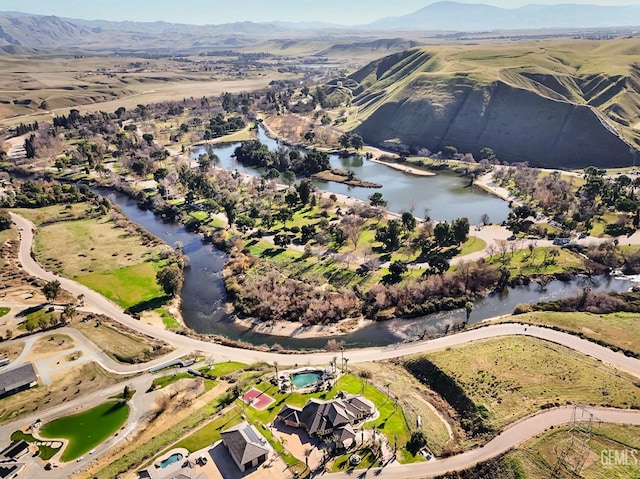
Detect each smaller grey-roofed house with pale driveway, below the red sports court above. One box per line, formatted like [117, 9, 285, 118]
[221, 421, 271, 472]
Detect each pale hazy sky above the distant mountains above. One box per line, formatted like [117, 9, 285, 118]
[0, 0, 640, 25]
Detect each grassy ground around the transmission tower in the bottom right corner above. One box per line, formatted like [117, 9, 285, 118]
[506, 424, 640, 479]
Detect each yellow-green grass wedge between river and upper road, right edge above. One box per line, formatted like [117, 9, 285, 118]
[496, 311, 640, 354]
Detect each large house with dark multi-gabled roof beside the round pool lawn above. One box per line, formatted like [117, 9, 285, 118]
[276, 391, 375, 447]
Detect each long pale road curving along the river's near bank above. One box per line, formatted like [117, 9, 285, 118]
[11, 213, 640, 377]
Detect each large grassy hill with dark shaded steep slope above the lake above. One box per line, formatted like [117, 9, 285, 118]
[342, 39, 640, 171]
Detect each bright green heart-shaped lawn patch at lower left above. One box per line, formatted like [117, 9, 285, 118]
[40, 402, 129, 462]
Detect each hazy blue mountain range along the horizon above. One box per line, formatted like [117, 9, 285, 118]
[0, 2, 640, 52]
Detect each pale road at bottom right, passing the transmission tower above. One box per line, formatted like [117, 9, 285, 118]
[322, 407, 640, 479]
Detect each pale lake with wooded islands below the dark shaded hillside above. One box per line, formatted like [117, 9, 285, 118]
[192, 129, 509, 224]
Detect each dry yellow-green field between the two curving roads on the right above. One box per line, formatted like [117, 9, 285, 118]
[426, 337, 640, 429]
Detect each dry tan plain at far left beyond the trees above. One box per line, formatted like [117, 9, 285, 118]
[0, 55, 287, 125]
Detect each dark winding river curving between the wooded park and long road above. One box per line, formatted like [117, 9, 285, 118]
[96, 190, 631, 349]
